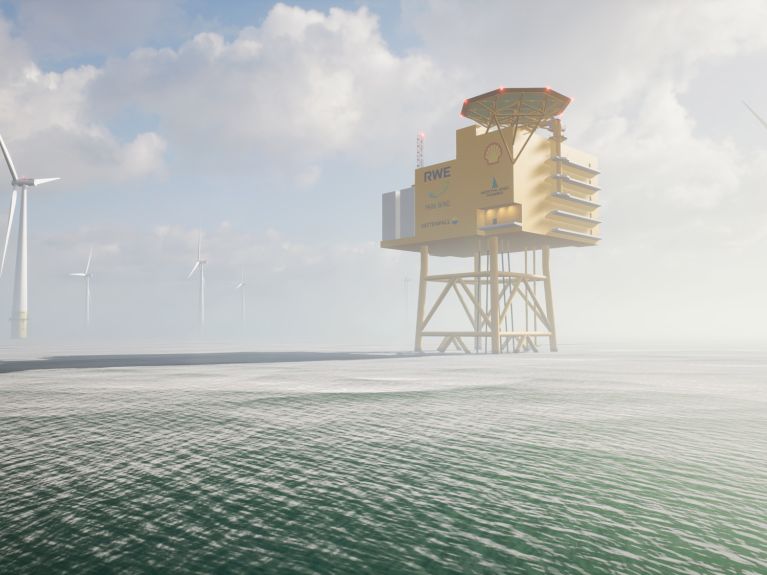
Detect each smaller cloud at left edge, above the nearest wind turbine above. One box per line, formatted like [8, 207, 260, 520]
[0, 15, 166, 189]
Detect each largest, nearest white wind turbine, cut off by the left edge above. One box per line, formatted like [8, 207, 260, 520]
[0, 132, 59, 339]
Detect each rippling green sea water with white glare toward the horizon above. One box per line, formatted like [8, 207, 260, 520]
[0, 350, 767, 575]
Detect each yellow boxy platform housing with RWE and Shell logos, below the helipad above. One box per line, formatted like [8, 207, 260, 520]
[381, 110, 599, 255]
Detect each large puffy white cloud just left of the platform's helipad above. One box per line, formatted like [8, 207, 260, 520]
[88, 4, 455, 180]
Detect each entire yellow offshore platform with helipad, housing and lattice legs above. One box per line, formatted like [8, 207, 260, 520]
[381, 88, 600, 353]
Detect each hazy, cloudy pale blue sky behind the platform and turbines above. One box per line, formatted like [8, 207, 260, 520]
[0, 0, 767, 349]
